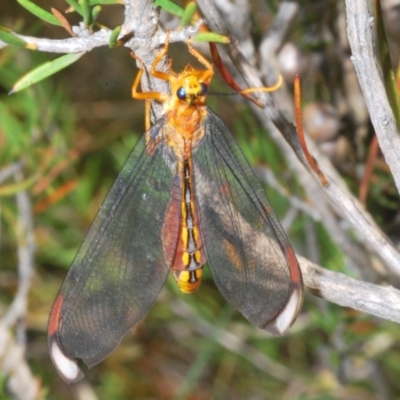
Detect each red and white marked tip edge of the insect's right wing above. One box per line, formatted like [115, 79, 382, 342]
[263, 245, 303, 336]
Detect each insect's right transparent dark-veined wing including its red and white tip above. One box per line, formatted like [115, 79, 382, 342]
[193, 110, 302, 334]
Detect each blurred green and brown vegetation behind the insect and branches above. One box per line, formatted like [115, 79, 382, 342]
[0, 0, 400, 400]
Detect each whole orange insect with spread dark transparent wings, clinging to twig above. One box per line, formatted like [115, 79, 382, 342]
[48, 38, 303, 382]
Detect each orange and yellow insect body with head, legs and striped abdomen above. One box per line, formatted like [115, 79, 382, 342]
[132, 45, 214, 293]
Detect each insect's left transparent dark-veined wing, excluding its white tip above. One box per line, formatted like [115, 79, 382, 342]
[49, 120, 174, 366]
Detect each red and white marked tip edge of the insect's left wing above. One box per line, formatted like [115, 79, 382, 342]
[48, 294, 84, 383]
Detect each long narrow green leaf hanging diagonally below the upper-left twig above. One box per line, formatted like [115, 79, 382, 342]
[10, 53, 85, 94]
